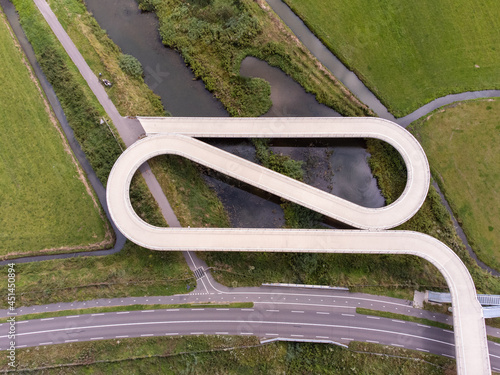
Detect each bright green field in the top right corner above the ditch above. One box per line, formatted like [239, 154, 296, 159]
[285, 0, 500, 117]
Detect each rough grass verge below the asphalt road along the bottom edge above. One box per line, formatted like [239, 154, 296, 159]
[1, 336, 455, 375]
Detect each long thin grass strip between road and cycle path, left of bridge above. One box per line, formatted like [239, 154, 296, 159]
[0, 302, 253, 323]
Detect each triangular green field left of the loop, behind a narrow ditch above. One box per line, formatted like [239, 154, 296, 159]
[0, 13, 111, 256]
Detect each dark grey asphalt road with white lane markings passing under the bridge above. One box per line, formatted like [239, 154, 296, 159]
[0, 303, 500, 371]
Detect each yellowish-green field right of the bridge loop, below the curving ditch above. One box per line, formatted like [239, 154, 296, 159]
[413, 99, 500, 269]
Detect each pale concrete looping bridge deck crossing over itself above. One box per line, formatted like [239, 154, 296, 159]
[107, 117, 491, 374]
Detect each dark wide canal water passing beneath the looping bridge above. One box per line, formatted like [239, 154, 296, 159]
[85, 0, 384, 228]
